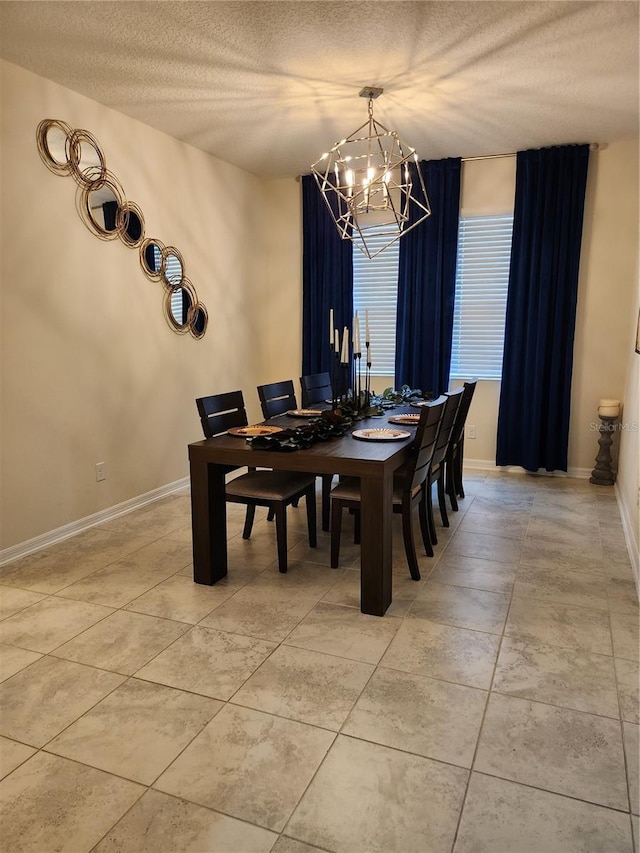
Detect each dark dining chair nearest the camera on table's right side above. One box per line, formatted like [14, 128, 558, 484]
[331, 397, 447, 581]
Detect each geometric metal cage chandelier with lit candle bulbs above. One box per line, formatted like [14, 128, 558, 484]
[311, 86, 431, 258]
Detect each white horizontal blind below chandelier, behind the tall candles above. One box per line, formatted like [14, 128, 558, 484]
[353, 229, 399, 376]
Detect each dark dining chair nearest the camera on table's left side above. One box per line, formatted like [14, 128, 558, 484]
[196, 391, 317, 573]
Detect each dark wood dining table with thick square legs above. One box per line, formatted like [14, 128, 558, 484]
[189, 410, 415, 616]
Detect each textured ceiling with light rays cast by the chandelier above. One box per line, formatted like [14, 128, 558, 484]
[0, 0, 639, 177]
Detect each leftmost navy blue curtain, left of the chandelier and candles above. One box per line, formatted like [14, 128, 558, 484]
[302, 175, 353, 376]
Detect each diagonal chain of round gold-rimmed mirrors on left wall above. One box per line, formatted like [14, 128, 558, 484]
[36, 119, 209, 339]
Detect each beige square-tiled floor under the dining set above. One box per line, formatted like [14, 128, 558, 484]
[0, 472, 640, 853]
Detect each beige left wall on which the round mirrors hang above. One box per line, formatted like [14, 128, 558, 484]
[0, 62, 284, 550]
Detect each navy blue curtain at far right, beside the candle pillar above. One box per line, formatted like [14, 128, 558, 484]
[496, 145, 589, 471]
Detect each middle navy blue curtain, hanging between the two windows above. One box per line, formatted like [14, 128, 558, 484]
[395, 157, 461, 397]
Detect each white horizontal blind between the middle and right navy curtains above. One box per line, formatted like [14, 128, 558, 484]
[451, 213, 513, 379]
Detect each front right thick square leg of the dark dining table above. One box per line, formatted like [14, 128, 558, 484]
[360, 472, 393, 616]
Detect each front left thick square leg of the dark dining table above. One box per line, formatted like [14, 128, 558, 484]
[190, 460, 227, 586]
